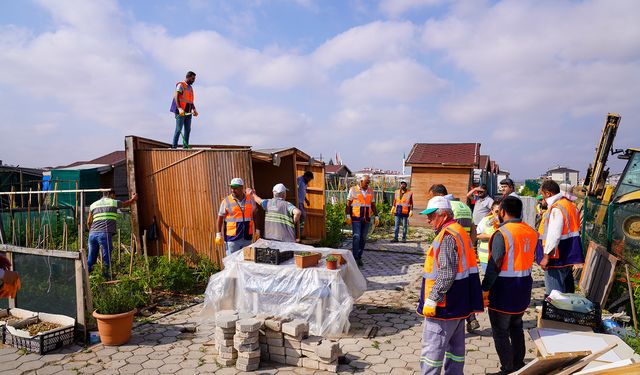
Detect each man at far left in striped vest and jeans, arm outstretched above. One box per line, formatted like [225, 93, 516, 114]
[87, 189, 138, 274]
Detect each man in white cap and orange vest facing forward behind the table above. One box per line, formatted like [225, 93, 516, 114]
[216, 177, 256, 255]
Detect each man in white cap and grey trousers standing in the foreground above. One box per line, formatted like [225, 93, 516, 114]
[416, 196, 484, 375]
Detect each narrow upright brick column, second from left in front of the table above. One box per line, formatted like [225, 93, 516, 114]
[233, 318, 262, 371]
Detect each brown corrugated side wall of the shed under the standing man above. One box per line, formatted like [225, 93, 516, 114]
[128, 140, 252, 262]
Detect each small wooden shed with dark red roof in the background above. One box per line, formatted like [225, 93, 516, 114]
[406, 143, 480, 225]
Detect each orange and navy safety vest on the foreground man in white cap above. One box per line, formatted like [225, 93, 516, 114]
[416, 221, 484, 319]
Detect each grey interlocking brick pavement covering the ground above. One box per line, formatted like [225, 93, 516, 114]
[0, 240, 543, 375]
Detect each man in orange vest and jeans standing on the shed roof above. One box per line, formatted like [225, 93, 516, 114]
[170, 71, 198, 148]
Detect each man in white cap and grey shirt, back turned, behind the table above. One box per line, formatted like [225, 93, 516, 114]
[247, 184, 302, 242]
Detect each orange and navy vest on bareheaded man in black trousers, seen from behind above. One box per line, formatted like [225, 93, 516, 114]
[489, 222, 538, 314]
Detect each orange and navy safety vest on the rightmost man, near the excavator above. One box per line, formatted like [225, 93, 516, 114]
[536, 197, 584, 268]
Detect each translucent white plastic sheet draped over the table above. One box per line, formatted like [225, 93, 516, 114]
[201, 239, 367, 337]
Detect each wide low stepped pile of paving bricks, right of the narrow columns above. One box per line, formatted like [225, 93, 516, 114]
[260, 318, 340, 372]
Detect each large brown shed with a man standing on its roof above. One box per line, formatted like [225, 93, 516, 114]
[125, 136, 325, 264]
